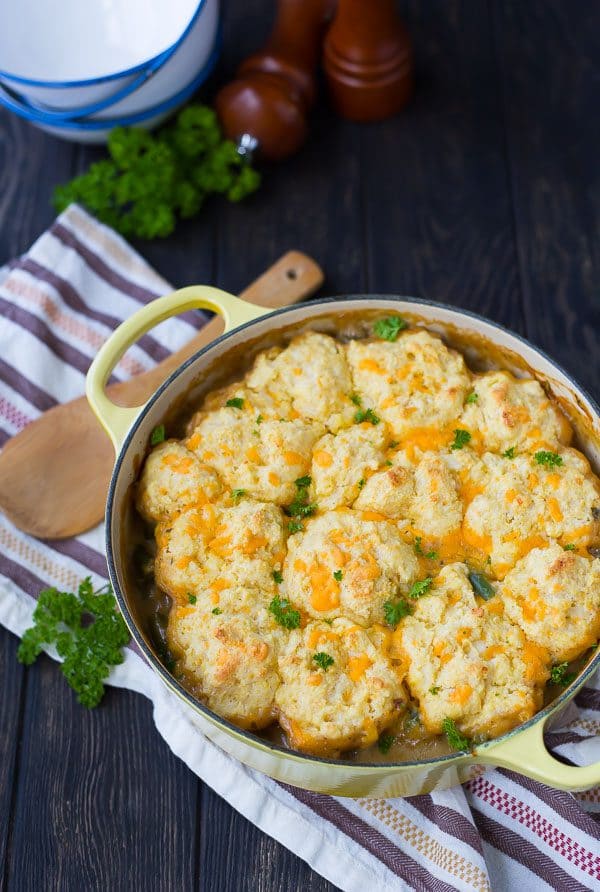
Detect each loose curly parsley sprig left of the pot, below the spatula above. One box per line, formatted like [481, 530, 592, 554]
[17, 576, 129, 709]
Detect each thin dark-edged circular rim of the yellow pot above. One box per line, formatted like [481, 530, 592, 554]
[105, 294, 600, 771]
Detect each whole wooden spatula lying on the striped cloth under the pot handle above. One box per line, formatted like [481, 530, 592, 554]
[0, 251, 323, 539]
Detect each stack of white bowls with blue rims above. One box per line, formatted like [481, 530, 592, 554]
[0, 0, 220, 143]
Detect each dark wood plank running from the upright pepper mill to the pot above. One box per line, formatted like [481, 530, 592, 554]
[360, 0, 522, 328]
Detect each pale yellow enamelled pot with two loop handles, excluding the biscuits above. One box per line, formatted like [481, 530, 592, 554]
[87, 286, 600, 797]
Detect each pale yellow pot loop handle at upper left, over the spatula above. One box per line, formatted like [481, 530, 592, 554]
[85, 285, 271, 453]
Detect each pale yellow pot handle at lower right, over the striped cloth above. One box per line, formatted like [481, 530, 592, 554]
[476, 716, 600, 791]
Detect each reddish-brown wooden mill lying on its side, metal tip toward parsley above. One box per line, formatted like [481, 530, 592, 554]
[215, 0, 335, 160]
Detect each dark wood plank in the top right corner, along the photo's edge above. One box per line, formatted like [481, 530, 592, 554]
[493, 0, 600, 396]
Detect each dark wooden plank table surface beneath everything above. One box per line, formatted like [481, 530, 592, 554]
[0, 0, 600, 892]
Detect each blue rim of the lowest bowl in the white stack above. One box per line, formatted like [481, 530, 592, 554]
[0, 26, 222, 132]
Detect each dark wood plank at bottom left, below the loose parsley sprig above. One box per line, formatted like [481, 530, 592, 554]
[8, 657, 198, 892]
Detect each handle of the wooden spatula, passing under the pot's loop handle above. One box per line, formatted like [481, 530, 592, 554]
[107, 251, 323, 406]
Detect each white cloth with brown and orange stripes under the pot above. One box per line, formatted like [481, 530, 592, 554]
[0, 206, 600, 892]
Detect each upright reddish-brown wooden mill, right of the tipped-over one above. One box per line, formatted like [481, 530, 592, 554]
[323, 0, 413, 121]
